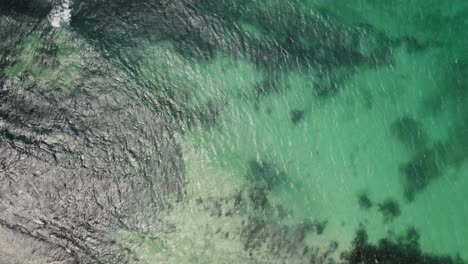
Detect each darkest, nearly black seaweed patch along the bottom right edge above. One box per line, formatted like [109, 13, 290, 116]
[342, 228, 464, 264]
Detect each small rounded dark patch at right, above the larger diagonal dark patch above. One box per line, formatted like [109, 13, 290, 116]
[391, 116, 427, 150]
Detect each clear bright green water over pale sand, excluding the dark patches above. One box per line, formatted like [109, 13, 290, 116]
[112, 1, 468, 263]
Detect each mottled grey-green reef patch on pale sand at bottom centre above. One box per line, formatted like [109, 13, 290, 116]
[192, 188, 330, 263]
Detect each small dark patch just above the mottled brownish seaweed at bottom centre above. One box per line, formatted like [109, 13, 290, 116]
[247, 160, 287, 191]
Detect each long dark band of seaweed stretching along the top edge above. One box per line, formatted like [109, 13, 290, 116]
[72, 1, 391, 80]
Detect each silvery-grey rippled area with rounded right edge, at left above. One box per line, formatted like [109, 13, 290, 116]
[0, 71, 183, 263]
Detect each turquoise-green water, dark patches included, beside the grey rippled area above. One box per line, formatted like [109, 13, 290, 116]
[3, 0, 468, 264]
